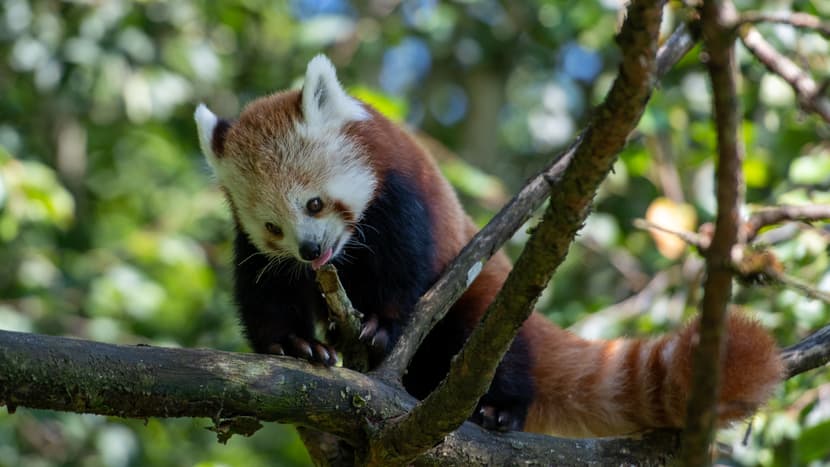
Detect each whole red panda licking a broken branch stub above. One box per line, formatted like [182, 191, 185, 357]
[195, 55, 782, 437]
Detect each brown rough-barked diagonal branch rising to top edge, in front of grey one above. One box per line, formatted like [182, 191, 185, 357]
[369, 0, 662, 464]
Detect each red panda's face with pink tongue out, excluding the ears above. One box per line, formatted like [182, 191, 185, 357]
[215, 128, 376, 267]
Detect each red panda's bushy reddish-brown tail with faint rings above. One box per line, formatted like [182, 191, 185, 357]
[522, 313, 783, 437]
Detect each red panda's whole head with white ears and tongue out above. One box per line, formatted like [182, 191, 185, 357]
[195, 55, 378, 269]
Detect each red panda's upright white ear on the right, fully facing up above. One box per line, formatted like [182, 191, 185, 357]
[303, 55, 369, 128]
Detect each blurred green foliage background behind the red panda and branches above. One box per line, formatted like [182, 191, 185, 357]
[0, 0, 830, 467]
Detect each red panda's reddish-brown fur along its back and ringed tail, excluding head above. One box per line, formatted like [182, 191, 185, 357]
[347, 99, 783, 437]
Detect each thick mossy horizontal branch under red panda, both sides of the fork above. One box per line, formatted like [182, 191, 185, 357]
[0, 331, 688, 466]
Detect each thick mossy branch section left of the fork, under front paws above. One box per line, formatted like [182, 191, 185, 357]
[0, 331, 406, 444]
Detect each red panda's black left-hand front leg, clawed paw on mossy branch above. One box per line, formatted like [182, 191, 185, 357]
[234, 227, 337, 366]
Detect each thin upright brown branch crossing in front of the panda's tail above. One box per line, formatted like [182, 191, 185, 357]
[680, 0, 743, 466]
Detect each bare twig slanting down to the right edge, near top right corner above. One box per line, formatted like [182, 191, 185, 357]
[740, 26, 830, 123]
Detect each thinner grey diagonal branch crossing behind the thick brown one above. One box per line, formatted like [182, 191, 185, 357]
[374, 11, 696, 381]
